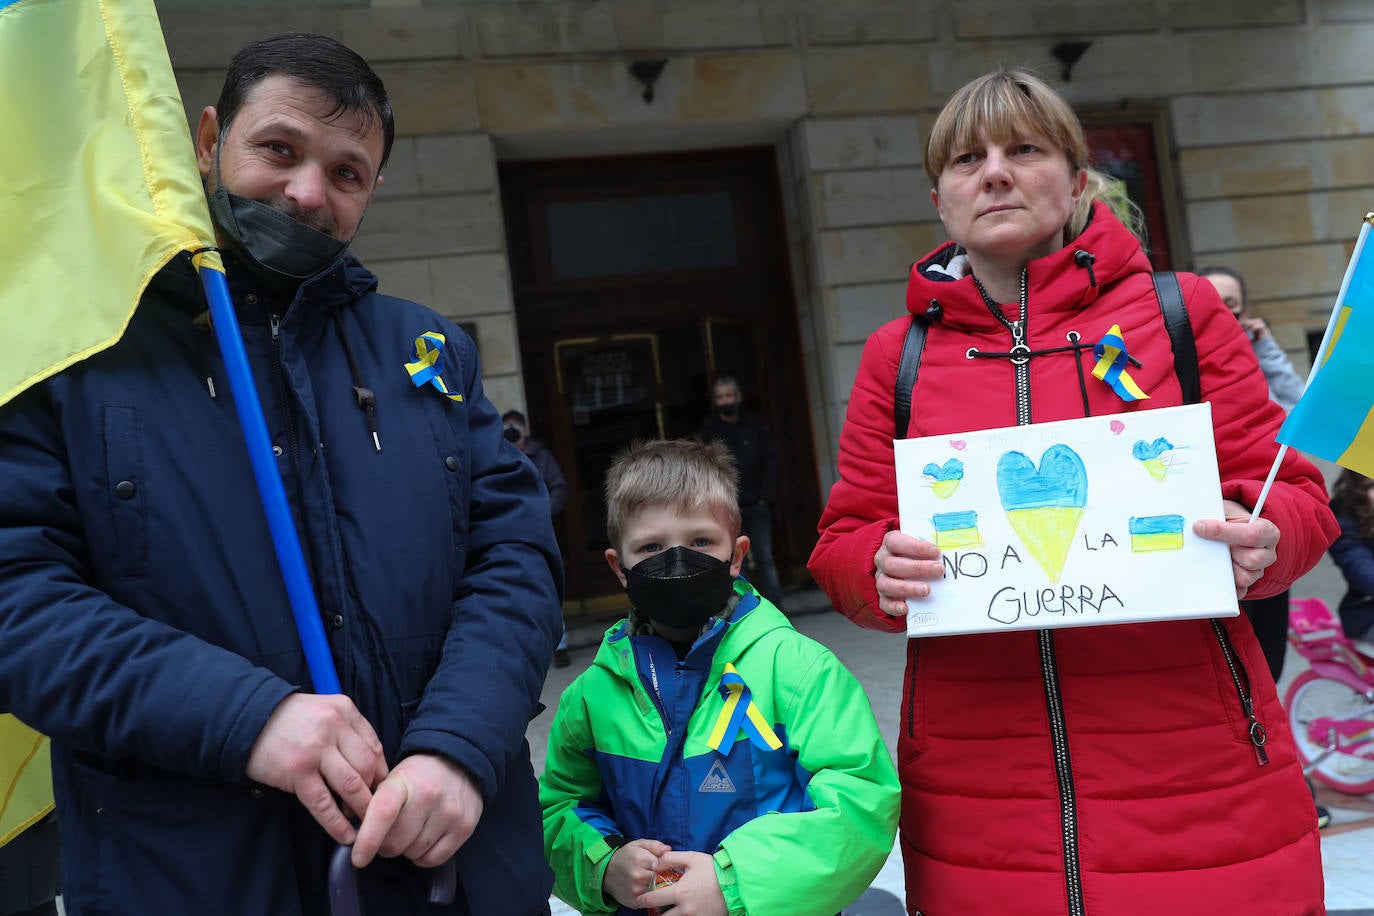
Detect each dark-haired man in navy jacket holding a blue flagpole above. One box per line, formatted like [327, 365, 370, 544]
[0, 34, 562, 916]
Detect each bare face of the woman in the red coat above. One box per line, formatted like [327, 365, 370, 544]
[930, 130, 1088, 272]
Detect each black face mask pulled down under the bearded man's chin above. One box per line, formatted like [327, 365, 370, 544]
[209, 140, 349, 287]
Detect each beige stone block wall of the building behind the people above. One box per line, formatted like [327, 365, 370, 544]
[159, 0, 1374, 486]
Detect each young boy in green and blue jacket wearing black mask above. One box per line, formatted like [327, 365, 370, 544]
[540, 439, 899, 916]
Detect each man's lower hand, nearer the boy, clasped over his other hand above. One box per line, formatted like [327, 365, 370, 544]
[353, 754, 484, 868]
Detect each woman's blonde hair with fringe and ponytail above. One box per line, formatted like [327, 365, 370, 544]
[925, 69, 1145, 244]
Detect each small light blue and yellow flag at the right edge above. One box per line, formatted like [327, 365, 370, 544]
[1278, 217, 1374, 477]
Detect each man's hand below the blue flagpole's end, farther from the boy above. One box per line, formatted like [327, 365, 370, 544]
[246, 694, 386, 843]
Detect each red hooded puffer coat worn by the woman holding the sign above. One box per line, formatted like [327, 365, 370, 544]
[809, 205, 1337, 916]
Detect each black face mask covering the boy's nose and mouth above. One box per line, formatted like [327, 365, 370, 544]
[625, 547, 734, 630]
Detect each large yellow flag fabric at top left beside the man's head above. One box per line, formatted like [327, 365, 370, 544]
[0, 0, 214, 405]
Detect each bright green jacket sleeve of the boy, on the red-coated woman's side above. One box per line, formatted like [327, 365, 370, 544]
[716, 648, 901, 916]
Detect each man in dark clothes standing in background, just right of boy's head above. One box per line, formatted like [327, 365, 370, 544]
[698, 375, 782, 603]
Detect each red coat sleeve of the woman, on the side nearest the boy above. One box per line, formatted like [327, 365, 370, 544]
[807, 317, 911, 633]
